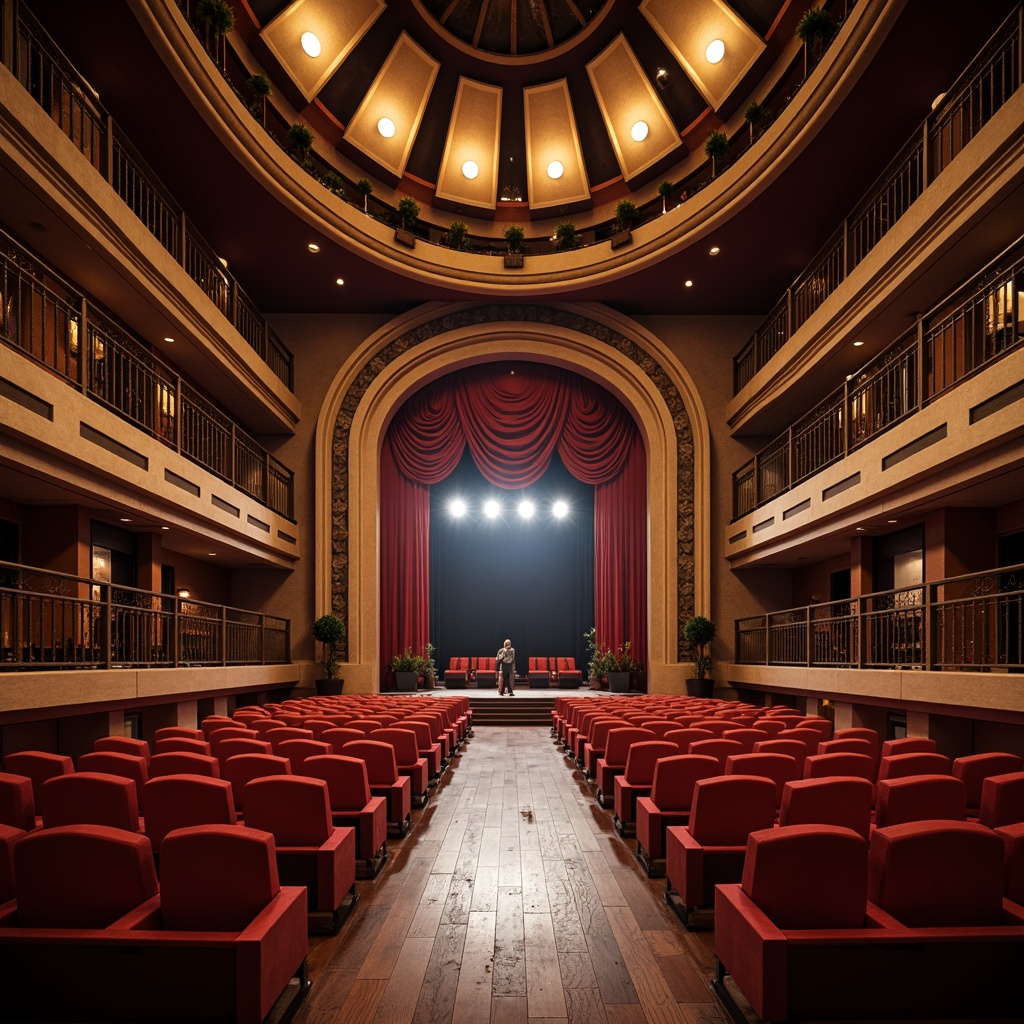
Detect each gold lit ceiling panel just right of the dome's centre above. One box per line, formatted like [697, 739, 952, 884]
[522, 79, 590, 210]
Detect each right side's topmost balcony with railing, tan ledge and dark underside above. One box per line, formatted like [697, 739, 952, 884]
[727, 7, 1024, 435]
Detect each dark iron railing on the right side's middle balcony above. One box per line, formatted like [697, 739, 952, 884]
[732, 239, 1024, 518]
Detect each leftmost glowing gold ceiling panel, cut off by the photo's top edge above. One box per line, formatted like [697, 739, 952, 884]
[260, 0, 387, 102]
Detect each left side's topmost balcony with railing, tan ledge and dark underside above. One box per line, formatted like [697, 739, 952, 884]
[0, 2, 300, 433]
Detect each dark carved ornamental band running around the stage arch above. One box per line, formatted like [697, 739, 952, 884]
[331, 303, 694, 660]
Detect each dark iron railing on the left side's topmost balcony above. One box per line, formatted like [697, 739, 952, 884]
[0, 0, 294, 389]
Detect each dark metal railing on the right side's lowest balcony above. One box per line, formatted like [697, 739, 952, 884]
[735, 565, 1024, 672]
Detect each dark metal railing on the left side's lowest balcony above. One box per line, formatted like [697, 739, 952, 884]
[0, 562, 291, 672]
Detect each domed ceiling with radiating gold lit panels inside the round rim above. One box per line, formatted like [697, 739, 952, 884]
[249, 0, 793, 217]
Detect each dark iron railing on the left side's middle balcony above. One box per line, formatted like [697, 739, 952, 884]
[0, 231, 295, 518]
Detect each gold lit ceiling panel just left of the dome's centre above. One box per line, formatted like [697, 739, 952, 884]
[436, 78, 502, 210]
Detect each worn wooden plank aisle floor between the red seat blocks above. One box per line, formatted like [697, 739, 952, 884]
[294, 726, 727, 1024]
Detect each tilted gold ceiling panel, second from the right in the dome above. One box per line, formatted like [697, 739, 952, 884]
[587, 35, 680, 181]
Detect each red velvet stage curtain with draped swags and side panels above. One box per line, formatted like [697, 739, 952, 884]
[380, 364, 647, 684]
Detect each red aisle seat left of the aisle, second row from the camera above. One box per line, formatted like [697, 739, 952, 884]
[245, 775, 355, 934]
